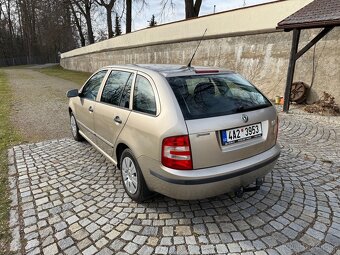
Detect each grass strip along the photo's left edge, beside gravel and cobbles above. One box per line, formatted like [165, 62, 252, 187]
[0, 70, 20, 254]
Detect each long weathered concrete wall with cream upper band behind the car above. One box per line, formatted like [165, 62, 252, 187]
[61, 0, 340, 103]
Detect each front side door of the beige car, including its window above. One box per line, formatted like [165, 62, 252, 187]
[75, 70, 107, 143]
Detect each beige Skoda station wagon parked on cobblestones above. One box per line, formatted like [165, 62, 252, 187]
[67, 65, 280, 202]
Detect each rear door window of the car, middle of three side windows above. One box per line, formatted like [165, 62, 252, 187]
[101, 71, 132, 105]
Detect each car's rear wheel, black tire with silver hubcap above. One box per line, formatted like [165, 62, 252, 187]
[120, 149, 152, 202]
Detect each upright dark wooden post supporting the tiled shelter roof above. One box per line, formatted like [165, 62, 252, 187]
[283, 29, 301, 113]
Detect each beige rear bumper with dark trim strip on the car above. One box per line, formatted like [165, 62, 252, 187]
[144, 145, 280, 200]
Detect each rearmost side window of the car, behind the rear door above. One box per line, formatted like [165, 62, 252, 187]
[133, 75, 156, 115]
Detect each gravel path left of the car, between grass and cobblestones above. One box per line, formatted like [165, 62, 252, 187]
[5, 69, 79, 142]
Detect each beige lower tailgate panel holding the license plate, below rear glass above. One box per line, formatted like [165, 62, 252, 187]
[186, 107, 276, 169]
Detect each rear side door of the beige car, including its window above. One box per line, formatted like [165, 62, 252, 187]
[94, 70, 135, 157]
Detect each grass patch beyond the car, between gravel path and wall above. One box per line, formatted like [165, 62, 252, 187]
[34, 66, 91, 85]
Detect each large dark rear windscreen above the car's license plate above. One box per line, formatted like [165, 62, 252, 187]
[167, 73, 271, 119]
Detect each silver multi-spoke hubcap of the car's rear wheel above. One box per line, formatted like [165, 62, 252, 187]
[122, 157, 138, 194]
